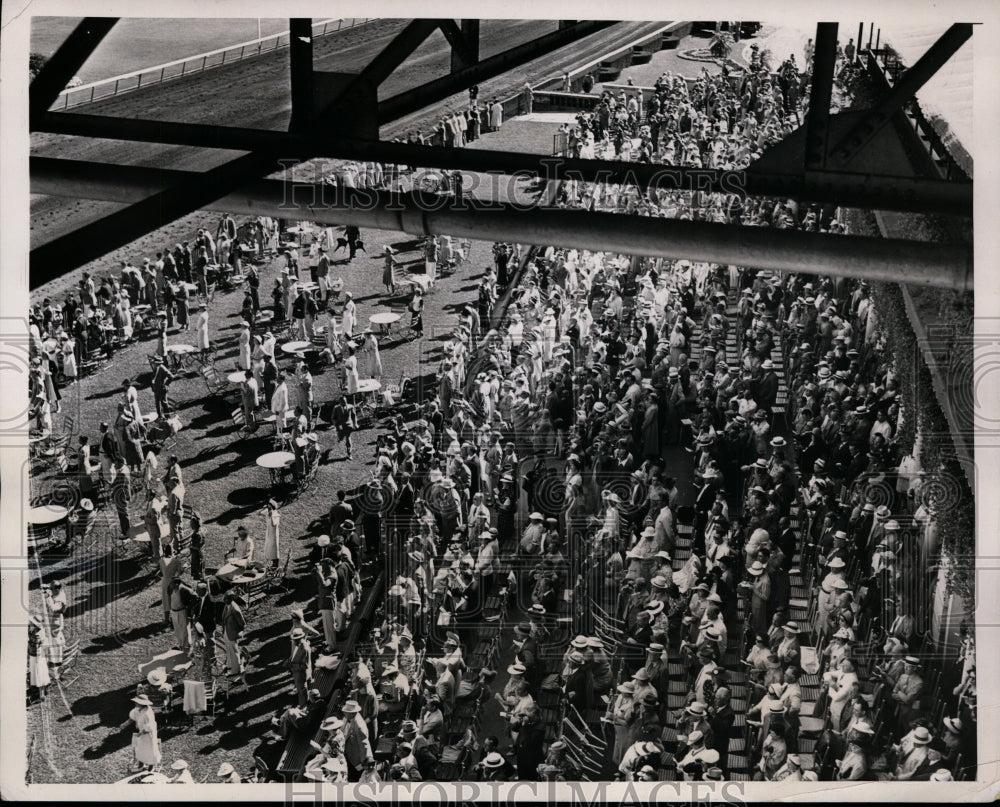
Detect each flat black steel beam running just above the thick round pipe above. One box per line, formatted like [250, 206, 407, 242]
[36, 112, 973, 215]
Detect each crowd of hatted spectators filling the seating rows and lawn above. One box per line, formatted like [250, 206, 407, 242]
[25, 34, 976, 782]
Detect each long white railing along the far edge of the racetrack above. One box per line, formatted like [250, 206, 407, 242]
[51, 18, 372, 109]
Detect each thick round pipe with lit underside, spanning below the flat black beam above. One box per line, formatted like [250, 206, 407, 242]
[31, 158, 973, 291]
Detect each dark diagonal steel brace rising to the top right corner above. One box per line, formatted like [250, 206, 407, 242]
[828, 23, 972, 167]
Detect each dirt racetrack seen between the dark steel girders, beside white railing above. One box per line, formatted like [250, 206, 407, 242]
[31, 20, 665, 301]
